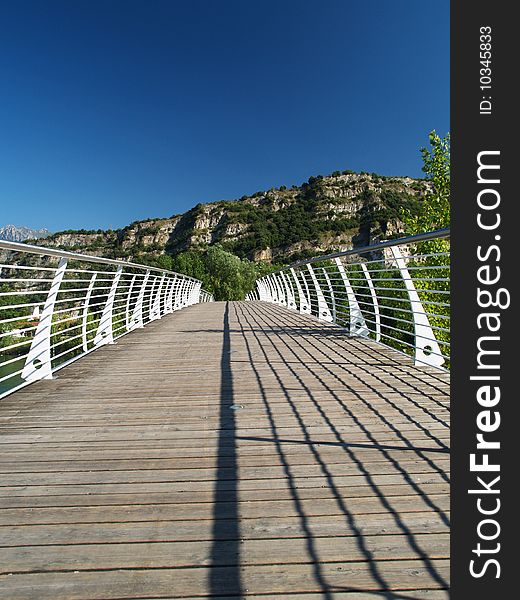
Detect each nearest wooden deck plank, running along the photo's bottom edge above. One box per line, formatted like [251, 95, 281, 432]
[0, 559, 449, 600]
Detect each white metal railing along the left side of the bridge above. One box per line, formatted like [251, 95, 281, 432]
[0, 241, 213, 398]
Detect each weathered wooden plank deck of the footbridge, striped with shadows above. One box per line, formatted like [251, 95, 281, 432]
[0, 302, 449, 600]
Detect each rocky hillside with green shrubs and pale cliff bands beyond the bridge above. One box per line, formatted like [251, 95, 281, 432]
[38, 171, 430, 263]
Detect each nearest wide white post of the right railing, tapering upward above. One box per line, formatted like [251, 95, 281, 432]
[390, 246, 444, 367]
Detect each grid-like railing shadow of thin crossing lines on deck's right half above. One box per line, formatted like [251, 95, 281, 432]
[235, 303, 449, 598]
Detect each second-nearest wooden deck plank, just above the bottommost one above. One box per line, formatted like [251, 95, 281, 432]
[0, 533, 449, 573]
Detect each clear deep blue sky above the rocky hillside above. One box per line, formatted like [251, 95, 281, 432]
[0, 0, 449, 231]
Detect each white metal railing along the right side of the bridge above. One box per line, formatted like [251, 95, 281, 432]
[246, 229, 450, 368]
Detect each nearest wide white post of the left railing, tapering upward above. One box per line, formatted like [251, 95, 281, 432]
[21, 258, 67, 381]
